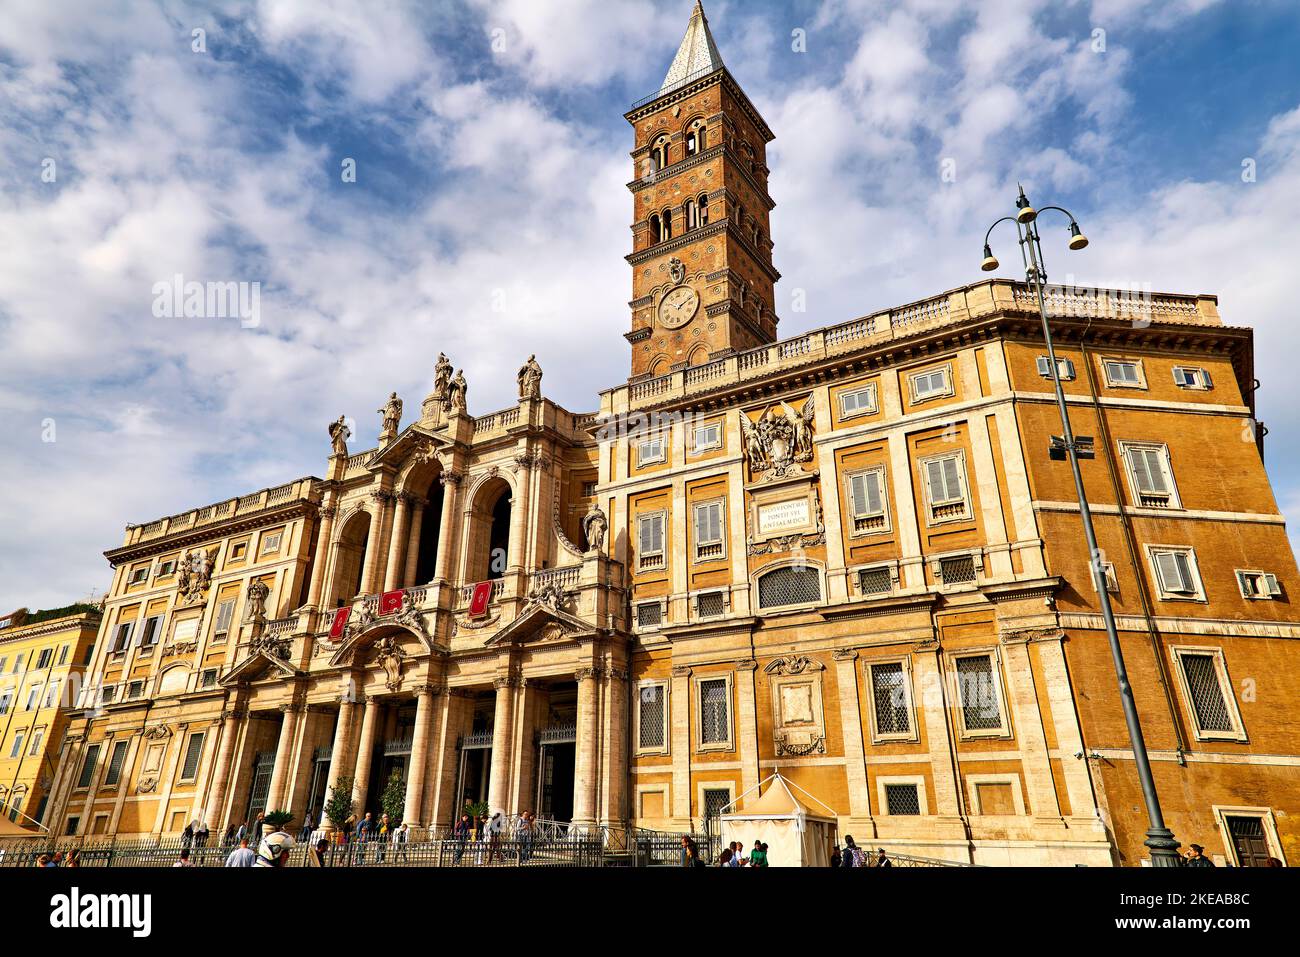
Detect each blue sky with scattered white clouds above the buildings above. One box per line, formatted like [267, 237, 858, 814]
[0, 0, 1300, 612]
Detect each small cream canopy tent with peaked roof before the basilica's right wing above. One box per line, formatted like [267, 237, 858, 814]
[720, 771, 839, 867]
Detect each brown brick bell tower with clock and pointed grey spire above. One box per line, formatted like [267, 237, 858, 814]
[625, 0, 780, 378]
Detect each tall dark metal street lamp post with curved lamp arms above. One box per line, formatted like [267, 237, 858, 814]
[980, 187, 1182, 867]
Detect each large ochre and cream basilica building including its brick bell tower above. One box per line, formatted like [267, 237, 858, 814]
[40, 4, 1300, 865]
